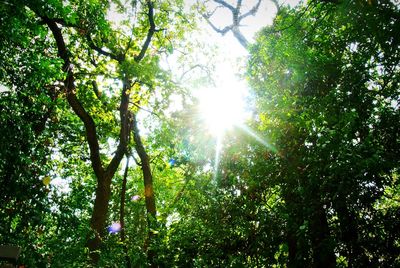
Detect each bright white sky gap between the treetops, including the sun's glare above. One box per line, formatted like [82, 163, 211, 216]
[187, 0, 299, 136]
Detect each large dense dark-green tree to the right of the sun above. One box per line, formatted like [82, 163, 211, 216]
[249, 1, 399, 267]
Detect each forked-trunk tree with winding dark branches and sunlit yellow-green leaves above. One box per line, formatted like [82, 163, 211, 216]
[1, 1, 188, 262]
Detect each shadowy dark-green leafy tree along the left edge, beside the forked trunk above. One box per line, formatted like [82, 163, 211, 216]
[0, 4, 61, 266]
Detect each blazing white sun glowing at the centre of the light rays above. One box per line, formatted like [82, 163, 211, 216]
[198, 82, 246, 136]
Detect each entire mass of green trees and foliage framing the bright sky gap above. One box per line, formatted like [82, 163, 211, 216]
[0, 0, 400, 267]
